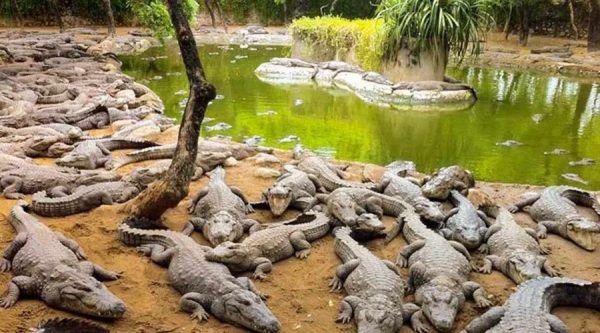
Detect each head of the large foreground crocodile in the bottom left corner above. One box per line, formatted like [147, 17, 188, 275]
[41, 265, 127, 318]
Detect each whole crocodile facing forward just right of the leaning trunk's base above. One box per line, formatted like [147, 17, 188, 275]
[183, 167, 258, 246]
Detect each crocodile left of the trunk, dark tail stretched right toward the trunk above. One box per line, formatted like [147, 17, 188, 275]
[56, 138, 157, 169]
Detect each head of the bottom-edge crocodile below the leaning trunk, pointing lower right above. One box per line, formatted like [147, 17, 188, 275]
[210, 286, 281, 333]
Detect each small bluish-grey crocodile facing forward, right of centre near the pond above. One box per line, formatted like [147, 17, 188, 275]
[440, 190, 490, 250]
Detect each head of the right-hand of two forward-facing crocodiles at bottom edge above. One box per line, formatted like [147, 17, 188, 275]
[415, 275, 465, 332]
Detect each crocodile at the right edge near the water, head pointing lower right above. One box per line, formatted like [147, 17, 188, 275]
[509, 186, 600, 251]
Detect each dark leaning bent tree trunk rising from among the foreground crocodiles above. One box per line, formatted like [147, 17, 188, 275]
[125, 0, 216, 223]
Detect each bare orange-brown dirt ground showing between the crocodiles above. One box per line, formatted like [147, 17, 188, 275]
[0, 125, 600, 333]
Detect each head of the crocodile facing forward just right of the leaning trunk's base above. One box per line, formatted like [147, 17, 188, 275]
[202, 210, 244, 246]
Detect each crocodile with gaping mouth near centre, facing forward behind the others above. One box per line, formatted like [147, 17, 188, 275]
[252, 165, 323, 216]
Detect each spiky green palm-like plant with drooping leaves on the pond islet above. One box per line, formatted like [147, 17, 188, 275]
[378, 0, 492, 67]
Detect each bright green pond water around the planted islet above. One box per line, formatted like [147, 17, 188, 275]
[122, 45, 600, 190]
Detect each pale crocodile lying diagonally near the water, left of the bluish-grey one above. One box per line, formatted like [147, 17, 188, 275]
[379, 163, 444, 224]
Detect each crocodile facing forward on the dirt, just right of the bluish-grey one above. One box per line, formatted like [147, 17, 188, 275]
[479, 208, 557, 284]
